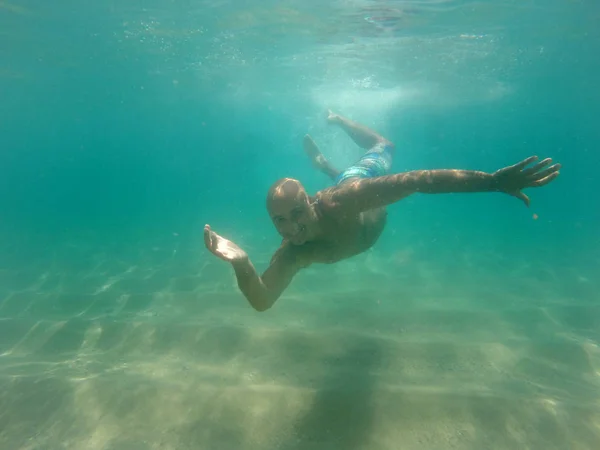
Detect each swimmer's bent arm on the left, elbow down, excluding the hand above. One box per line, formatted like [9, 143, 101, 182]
[232, 246, 300, 311]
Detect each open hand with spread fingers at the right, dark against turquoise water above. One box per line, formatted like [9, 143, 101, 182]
[493, 156, 561, 207]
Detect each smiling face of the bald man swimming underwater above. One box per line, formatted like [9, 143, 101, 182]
[268, 184, 316, 245]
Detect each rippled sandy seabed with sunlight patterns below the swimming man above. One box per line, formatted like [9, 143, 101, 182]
[0, 241, 600, 450]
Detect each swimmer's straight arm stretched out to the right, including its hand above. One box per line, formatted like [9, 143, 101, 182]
[324, 156, 560, 211]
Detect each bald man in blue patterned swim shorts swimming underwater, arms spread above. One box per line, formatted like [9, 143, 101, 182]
[204, 111, 560, 311]
